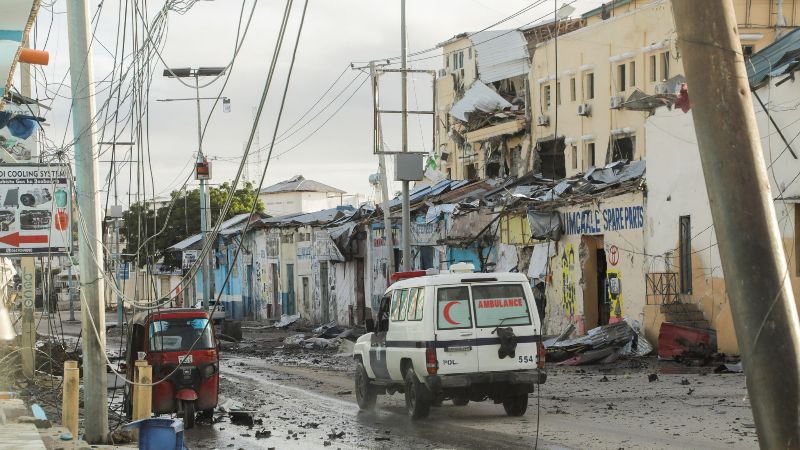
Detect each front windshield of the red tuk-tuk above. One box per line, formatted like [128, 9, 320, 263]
[147, 318, 214, 352]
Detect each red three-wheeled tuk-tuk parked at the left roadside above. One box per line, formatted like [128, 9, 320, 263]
[125, 308, 219, 428]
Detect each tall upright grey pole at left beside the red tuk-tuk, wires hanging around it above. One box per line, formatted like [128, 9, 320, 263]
[67, 0, 108, 444]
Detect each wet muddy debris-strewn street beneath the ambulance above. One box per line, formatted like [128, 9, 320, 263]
[180, 331, 757, 449]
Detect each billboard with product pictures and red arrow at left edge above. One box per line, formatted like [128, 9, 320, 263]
[0, 164, 72, 256]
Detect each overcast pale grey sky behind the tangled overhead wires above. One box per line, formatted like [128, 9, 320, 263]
[20, 0, 601, 204]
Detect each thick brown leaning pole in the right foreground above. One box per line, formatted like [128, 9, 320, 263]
[672, 0, 800, 448]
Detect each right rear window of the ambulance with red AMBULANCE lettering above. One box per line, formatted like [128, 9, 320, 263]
[472, 284, 531, 328]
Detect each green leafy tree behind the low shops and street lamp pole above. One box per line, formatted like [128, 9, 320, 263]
[120, 182, 264, 267]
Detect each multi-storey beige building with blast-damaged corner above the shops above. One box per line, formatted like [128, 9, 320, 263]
[436, 0, 800, 179]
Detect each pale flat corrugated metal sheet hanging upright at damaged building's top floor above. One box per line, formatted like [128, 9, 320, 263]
[469, 30, 530, 83]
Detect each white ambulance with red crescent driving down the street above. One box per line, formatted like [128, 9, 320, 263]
[353, 265, 547, 418]
